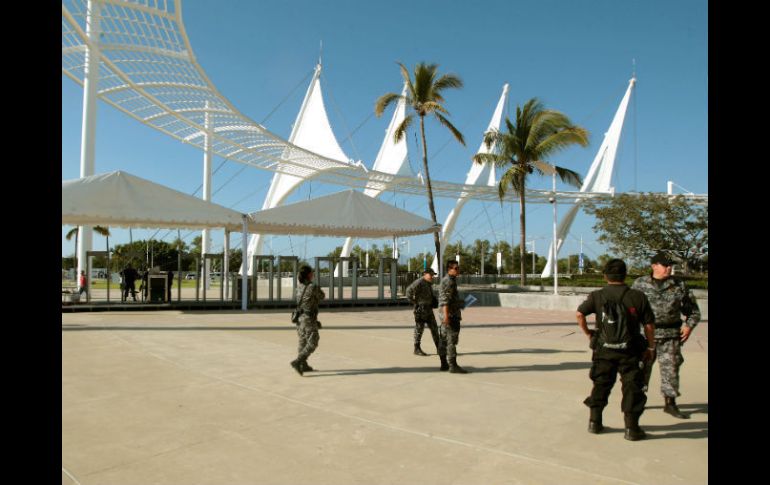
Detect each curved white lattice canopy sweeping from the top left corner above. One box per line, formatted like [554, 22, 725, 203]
[62, 0, 648, 202]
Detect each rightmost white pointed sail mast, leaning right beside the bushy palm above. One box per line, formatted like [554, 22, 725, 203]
[541, 78, 636, 278]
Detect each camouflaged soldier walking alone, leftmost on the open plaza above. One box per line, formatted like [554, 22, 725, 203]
[291, 266, 326, 375]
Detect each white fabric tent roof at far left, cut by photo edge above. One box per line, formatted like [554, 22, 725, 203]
[61, 170, 251, 232]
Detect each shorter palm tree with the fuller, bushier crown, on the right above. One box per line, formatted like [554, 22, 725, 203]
[473, 98, 588, 286]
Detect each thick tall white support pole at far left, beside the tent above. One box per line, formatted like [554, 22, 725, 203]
[77, 0, 100, 279]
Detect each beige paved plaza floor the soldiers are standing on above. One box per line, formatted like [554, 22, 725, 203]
[61, 307, 708, 485]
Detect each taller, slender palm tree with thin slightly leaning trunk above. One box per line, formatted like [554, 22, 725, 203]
[374, 62, 465, 272]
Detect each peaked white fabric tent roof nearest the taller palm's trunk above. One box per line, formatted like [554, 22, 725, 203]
[249, 189, 441, 238]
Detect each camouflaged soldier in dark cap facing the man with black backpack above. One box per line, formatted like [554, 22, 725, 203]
[632, 252, 700, 419]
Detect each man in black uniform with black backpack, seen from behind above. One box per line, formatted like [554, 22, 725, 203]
[576, 259, 655, 441]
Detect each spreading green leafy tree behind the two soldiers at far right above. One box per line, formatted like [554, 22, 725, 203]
[585, 193, 708, 274]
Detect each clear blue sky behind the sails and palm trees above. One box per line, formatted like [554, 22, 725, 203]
[62, 0, 708, 264]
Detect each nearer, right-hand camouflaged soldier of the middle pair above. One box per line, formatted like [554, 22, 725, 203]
[438, 260, 468, 374]
